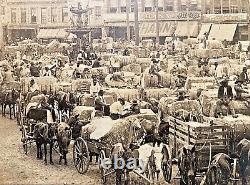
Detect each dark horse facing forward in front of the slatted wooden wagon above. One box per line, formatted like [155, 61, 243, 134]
[177, 145, 197, 185]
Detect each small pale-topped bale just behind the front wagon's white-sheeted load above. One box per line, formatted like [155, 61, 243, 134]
[73, 106, 95, 123]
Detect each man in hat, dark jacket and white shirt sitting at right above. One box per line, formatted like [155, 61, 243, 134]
[214, 78, 237, 118]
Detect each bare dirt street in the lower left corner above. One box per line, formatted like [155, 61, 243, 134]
[0, 117, 100, 185]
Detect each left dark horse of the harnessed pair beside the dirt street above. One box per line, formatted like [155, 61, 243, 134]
[34, 122, 56, 165]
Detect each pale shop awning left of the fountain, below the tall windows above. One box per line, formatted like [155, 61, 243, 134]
[37, 29, 69, 39]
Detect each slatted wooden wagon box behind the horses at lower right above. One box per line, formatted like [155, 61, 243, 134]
[168, 116, 232, 169]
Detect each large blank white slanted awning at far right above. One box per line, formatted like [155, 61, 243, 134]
[208, 24, 237, 41]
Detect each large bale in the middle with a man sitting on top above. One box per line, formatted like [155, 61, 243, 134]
[141, 68, 178, 88]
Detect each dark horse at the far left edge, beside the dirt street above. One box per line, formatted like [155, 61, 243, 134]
[2, 89, 20, 119]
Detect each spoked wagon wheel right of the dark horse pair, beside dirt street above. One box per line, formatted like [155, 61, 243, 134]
[73, 138, 90, 174]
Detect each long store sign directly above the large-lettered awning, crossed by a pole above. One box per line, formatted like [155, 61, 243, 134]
[141, 11, 201, 21]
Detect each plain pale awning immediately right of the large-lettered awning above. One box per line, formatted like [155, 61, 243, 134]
[175, 21, 198, 37]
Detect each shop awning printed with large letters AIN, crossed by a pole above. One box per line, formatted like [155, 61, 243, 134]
[140, 22, 176, 37]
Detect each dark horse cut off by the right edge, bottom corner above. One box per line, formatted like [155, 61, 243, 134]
[236, 139, 250, 185]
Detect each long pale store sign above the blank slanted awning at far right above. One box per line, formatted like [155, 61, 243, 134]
[203, 13, 247, 23]
